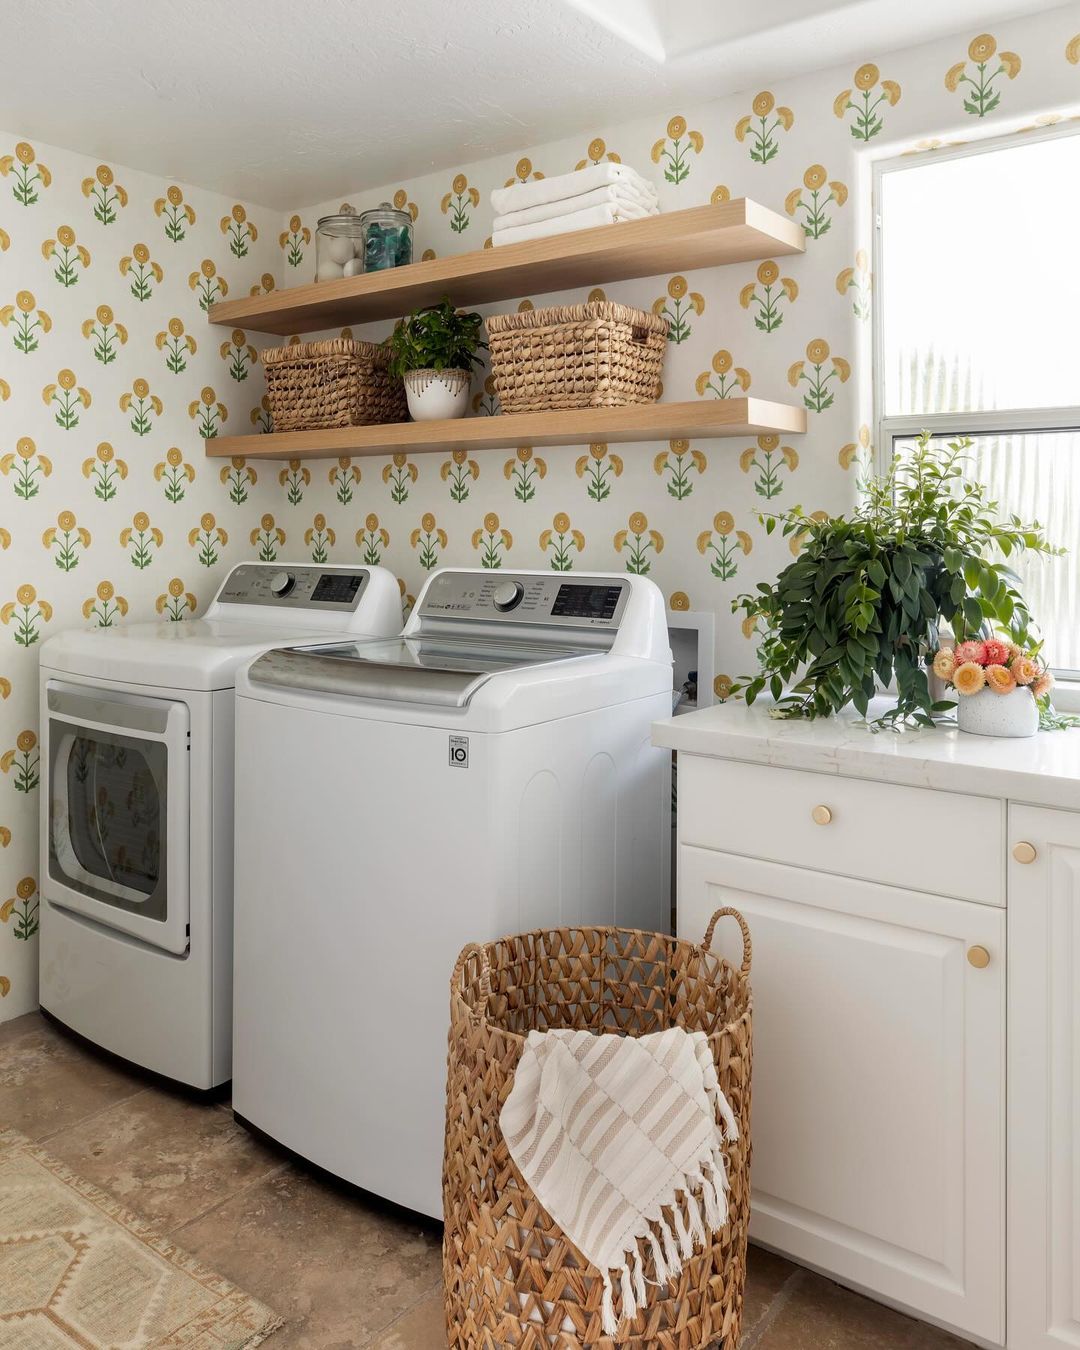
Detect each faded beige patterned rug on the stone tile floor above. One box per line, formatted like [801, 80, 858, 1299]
[0, 1130, 282, 1350]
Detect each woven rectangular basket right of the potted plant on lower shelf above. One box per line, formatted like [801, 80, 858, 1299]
[486, 301, 667, 413]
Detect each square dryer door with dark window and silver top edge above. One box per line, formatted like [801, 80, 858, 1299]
[42, 680, 190, 954]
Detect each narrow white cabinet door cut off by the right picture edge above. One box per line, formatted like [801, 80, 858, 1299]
[1008, 806, 1080, 1350]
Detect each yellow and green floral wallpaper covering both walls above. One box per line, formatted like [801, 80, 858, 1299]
[0, 4, 1080, 1019]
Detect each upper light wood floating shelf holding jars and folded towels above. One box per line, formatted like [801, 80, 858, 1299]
[209, 197, 806, 336]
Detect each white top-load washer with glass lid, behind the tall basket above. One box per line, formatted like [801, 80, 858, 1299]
[232, 570, 671, 1216]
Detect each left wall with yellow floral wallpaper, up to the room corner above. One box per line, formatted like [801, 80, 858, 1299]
[0, 142, 279, 1018]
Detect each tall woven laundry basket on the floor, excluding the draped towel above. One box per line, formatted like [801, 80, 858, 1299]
[443, 907, 751, 1350]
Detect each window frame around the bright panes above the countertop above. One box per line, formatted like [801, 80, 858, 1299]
[871, 122, 1080, 711]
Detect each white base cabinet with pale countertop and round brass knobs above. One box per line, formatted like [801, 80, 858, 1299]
[653, 702, 1080, 1350]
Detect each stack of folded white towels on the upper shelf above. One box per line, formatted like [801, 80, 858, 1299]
[491, 161, 660, 246]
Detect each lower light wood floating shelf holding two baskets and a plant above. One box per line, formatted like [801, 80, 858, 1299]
[205, 398, 806, 459]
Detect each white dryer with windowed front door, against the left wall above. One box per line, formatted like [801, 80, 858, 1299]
[41, 563, 401, 1089]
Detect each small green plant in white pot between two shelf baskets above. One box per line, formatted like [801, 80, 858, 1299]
[389, 296, 487, 421]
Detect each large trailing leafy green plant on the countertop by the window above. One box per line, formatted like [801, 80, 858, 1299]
[732, 433, 1064, 725]
